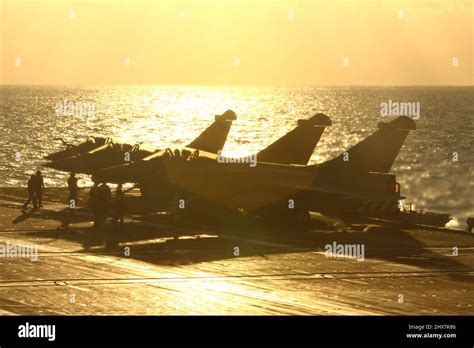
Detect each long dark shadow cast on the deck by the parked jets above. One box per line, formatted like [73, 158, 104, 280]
[21, 209, 474, 282]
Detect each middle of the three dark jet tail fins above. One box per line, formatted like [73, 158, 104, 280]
[257, 114, 332, 165]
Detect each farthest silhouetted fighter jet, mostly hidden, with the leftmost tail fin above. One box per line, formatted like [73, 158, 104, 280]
[44, 110, 236, 174]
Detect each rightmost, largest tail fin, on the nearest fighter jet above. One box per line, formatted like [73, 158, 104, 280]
[320, 116, 416, 173]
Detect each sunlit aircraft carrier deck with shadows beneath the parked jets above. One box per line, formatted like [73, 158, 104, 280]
[0, 188, 474, 315]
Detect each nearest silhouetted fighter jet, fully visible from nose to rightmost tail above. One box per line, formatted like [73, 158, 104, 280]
[97, 116, 416, 220]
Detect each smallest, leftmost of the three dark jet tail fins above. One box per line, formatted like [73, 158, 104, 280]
[186, 110, 237, 153]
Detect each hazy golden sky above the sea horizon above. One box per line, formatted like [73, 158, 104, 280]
[0, 0, 473, 86]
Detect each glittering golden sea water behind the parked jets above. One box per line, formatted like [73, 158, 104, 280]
[0, 86, 474, 227]
